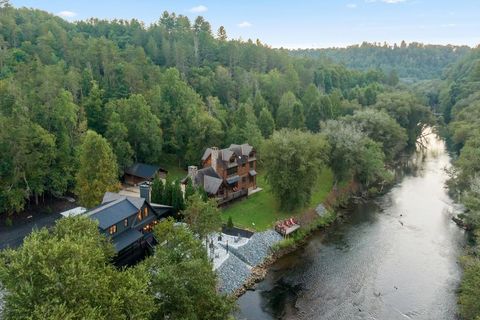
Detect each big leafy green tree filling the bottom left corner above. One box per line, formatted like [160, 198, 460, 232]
[0, 217, 153, 319]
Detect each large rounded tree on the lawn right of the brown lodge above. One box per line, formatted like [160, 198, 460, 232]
[262, 130, 330, 210]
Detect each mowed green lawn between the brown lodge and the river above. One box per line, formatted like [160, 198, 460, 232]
[222, 168, 333, 231]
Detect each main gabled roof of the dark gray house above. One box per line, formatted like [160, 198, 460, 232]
[85, 192, 145, 230]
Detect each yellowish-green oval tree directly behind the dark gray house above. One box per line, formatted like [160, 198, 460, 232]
[75, 131, 119, 207]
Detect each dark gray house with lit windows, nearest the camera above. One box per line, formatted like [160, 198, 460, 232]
[85, 192, 171, 256]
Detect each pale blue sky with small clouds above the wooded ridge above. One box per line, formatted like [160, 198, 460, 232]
[10, 0, 480, 48]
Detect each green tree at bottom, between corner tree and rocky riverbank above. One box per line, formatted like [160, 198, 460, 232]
[146, 219, 234, 320]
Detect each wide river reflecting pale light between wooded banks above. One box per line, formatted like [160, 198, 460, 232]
[237, 135, 466, 320]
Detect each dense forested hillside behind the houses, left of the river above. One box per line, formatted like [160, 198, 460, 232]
[0, 5, 435, 215]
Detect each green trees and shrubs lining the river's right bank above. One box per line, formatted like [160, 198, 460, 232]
[440, 48, 480, 320]
